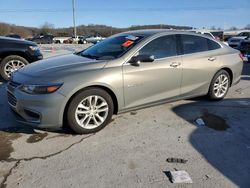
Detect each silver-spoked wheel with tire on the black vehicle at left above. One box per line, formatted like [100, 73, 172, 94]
[0, 55, 29, 80]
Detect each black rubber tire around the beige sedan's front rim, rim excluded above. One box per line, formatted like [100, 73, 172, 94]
[67, 88, 114, 134]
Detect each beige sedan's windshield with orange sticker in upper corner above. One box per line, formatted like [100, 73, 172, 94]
[79, 35, 143, 59]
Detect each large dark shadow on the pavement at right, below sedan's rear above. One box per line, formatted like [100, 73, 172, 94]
[172, 98, 250, 187]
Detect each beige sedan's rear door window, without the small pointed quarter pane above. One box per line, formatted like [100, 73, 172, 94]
[181, 35, 208, 54]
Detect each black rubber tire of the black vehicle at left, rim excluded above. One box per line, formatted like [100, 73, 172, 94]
[0, 55, 29, 80]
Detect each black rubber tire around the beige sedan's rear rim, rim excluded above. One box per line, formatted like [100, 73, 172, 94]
[208, 70, 231, 100]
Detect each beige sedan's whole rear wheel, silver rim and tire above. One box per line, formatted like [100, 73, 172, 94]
[208, 70, 230, 100]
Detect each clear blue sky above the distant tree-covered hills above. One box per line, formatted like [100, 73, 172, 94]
[0, 0, 250, 29]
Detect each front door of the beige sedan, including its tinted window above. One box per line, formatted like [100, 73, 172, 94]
[123, 35, 182, 108]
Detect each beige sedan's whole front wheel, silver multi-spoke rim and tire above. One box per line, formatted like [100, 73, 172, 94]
[67, 88, 114, 134]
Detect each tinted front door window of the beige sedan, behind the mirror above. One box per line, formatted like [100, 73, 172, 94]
[139, 35, 177, 59]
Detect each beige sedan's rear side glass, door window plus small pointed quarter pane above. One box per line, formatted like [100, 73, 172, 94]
[181, 35, 221, 54]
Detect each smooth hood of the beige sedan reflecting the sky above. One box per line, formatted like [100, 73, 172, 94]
[14, 54, 106, 78]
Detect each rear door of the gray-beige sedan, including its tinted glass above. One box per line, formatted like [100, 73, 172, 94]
[179, 34, 221, 97]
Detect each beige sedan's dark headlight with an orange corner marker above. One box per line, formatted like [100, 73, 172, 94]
[20, 84, 62, 94]
